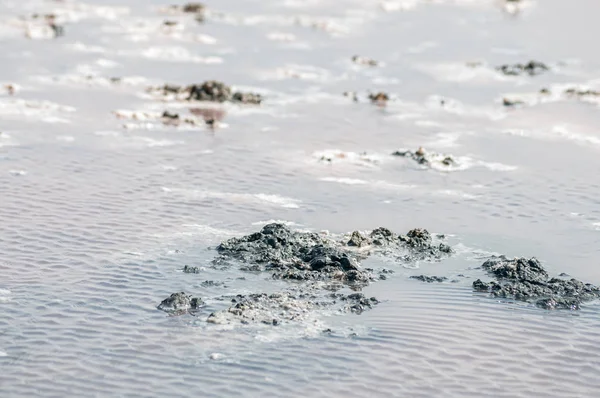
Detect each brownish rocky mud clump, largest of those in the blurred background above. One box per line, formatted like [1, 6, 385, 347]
[146, 80, 263, 105]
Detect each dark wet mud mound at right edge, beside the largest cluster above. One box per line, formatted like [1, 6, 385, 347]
[473, 256, 600, 309]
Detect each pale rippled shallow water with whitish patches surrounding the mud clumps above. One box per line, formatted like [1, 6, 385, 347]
[0, 0, 600, 397]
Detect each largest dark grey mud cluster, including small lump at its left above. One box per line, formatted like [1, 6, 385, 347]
[158, 223, 452, 325]
